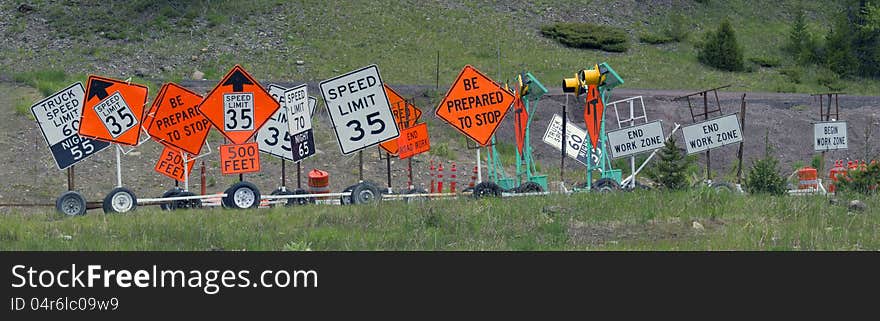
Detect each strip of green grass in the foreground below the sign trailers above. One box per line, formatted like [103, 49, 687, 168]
[0, 190, 880, 251]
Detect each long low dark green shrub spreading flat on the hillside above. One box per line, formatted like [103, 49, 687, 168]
[541, 22, 629, 52]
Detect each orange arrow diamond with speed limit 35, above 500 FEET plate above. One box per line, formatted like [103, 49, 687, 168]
[199, 65, 281, 144]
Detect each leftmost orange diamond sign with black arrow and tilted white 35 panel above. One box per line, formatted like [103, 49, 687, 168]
[79, 75, 147, 146]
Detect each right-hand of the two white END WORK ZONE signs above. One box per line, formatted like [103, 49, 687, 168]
[681, 114, 743, 154]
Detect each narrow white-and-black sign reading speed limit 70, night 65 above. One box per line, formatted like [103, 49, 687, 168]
[284, 84, 315, 162]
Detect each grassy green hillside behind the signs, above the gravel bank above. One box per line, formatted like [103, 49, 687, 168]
[0, 0, 880, 94]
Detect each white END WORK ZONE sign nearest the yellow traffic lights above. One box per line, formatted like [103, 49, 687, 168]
[607, 120, 666, 158]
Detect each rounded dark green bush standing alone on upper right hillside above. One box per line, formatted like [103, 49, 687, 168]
[697, 20, 745, 71]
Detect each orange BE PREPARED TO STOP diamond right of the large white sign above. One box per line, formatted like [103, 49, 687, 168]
[434, 65, 513, 146]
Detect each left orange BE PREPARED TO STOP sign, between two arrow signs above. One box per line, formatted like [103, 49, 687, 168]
[144, 83, 211, 155]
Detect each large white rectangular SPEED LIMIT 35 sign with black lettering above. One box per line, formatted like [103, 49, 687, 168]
[320, 65, 400, 155]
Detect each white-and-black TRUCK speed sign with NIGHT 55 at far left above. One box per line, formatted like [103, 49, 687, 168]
[31, 83, 110, 169]
